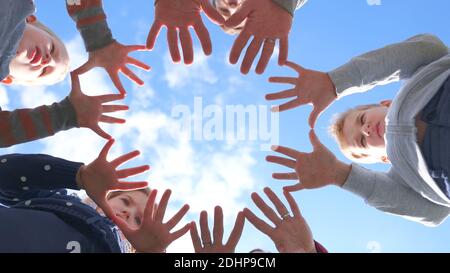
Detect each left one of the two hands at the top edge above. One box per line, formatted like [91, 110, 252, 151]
[147, 0, 225, 64]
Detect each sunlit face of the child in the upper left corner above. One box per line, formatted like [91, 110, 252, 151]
[9, 24, 69, 85]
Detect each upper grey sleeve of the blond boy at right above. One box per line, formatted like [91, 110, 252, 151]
[328, 34, 448, 97]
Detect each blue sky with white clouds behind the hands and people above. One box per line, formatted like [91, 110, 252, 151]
[4, 0, 450, 252]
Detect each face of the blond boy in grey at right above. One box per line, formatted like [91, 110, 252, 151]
[342, 102, 390, 161]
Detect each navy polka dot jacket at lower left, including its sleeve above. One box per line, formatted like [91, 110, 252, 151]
[0, 154, 121, 253]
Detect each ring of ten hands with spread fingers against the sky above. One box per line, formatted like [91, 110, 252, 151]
[69, 0, 339, 253]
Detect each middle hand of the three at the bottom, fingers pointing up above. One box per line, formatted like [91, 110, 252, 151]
[191, 206, 245, 253]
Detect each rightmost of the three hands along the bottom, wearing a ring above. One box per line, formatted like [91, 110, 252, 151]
[244, 188, 316, 253]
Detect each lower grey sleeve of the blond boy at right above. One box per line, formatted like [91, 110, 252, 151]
[343, 164, 450, 226]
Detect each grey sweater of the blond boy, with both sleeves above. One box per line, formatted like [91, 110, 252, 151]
[329, 35, 450, 226]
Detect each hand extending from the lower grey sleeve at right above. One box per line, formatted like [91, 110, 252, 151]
[266, 130, 351, 192]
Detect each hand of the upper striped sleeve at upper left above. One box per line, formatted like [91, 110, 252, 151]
[74, 41, 151, 95]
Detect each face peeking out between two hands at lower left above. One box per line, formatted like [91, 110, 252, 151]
[108, 191, 148, 229]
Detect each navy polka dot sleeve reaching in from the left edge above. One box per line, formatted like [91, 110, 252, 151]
[0, 154, 83, 197]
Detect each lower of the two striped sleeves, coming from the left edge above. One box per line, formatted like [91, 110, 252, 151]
[0, 95, 78, 147]
